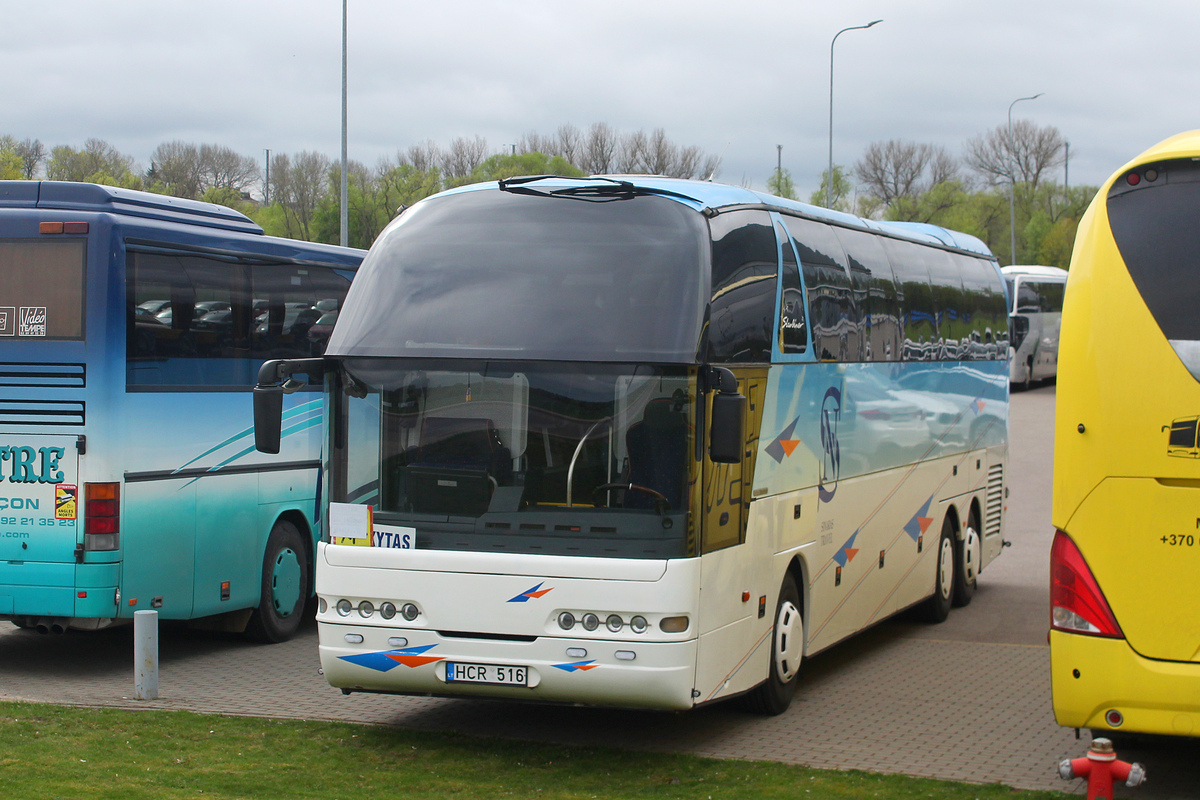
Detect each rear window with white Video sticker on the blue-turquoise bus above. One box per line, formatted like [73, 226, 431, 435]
[0, 239, 85, 342]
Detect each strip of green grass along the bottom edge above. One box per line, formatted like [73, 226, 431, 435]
[0, 703, 1064, 800]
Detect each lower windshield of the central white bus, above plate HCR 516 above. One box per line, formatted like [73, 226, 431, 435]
[331, 359, 695, 559]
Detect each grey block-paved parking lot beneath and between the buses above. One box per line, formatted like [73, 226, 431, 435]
[0, 386, 1200, 800]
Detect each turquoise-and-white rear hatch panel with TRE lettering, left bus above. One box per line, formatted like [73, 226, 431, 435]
[0, 434, 83, 616]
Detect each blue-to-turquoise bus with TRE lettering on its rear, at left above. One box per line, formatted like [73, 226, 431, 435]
[0, 181, 364, 642]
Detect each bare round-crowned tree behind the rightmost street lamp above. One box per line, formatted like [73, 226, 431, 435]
[964, 120, 1066, 197]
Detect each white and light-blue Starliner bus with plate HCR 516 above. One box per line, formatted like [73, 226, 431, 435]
[256, 176, 1008, 714]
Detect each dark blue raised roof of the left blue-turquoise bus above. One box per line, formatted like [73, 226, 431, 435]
[0, 181, 263, 235]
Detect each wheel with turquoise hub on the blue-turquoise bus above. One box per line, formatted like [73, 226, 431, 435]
[246, 519, 310, 643]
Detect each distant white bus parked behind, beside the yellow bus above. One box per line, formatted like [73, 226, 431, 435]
[1000, 265, 1067, 389]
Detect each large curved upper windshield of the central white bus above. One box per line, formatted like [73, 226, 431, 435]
[328, 190, 710, 363]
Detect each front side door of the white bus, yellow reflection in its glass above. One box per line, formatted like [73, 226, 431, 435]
[696, 367, 778, 703]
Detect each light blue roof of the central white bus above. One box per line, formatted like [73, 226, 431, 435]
[448, 175, 994, 258]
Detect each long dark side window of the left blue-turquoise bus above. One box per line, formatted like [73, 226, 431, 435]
[126, 248, 350, 386]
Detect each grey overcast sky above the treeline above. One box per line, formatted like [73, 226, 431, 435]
[0, 0, 1200, 197]
